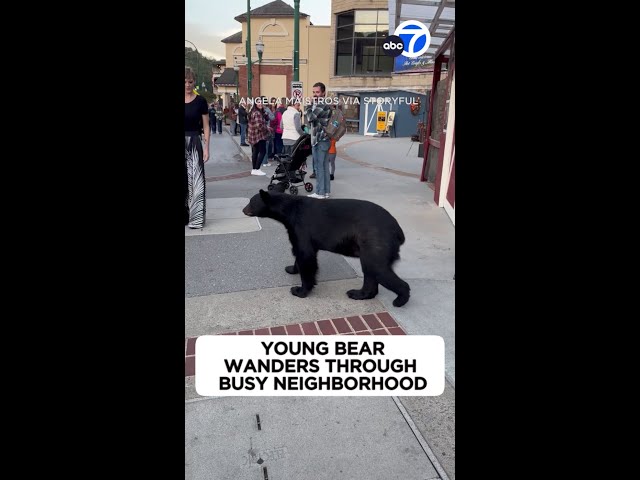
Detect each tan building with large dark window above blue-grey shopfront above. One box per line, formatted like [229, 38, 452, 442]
[328, 0, 431, 137]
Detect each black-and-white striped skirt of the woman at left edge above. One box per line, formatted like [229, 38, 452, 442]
[184, 132, 207, 228]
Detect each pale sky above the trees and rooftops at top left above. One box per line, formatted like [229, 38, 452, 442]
[184, 0, 331, 60]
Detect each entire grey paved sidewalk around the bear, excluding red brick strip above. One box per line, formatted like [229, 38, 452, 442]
[185, 127, 455, 479]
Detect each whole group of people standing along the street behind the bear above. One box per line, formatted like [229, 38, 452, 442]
[184, 67, 336, 229]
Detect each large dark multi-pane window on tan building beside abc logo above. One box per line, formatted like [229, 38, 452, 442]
[335, 10, 393, 76]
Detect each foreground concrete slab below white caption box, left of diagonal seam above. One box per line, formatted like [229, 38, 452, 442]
[185, 397, 441, 480]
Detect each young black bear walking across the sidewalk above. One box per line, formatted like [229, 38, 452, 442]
[242, 190, 411, 307]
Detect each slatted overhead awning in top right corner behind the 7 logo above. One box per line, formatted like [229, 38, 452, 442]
[389, 0, 456, 60]
